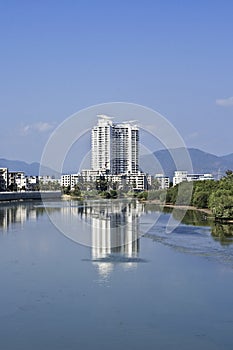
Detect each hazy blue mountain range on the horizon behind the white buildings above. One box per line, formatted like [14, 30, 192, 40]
[0, 148, 233, 178]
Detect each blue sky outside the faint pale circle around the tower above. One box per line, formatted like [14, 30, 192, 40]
[0, 0, 233, 162]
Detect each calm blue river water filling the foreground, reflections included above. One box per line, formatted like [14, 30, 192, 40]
[0, 201, 233, 350]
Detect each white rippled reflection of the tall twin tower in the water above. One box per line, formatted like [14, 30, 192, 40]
[79, 201, 143, 277]
